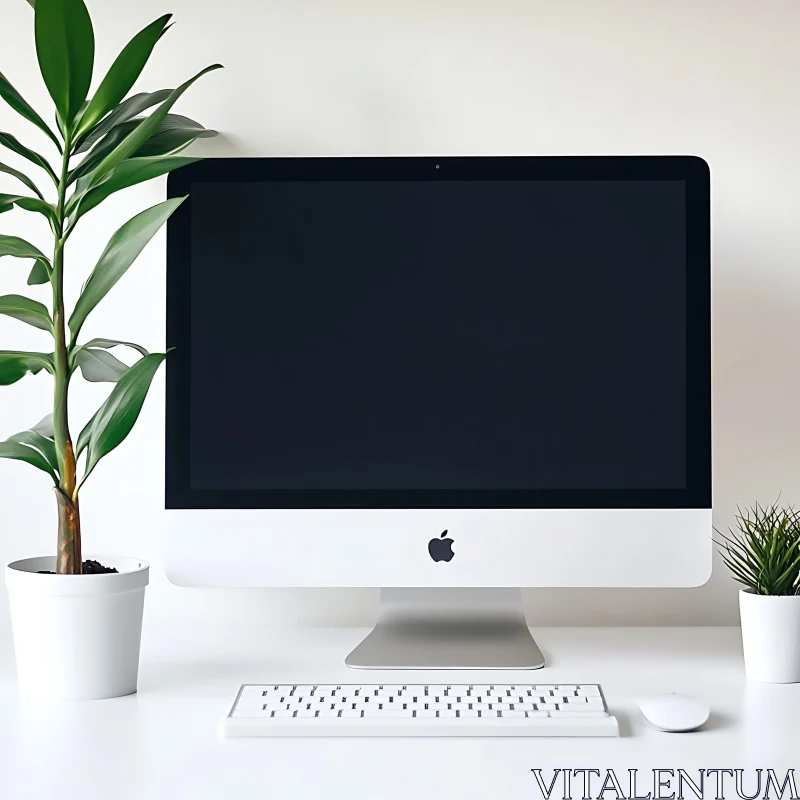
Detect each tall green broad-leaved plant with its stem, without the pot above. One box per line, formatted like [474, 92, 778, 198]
[0, 0, 220, 574]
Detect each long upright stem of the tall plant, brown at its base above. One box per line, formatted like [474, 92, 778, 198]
[52, 130, 81, 575]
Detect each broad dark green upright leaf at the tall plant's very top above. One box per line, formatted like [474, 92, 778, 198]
[34, 0, 94, 125]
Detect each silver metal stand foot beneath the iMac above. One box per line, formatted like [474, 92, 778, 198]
[345, 589, 544, 669]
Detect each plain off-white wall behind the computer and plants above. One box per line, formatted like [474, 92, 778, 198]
[0, 0, 800, 626]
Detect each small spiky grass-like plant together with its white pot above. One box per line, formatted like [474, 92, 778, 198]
[717, 503, 800, 683]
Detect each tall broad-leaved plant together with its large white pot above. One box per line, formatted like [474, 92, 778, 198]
[0, 0, 220, 699]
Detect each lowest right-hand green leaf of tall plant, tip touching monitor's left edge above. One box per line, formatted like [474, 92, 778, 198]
[79, 353, 167, 484]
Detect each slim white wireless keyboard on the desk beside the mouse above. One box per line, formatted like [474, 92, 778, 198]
[221, 684, 619, 737]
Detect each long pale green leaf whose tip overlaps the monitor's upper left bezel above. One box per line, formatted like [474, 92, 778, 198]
[69, 197, 186, 340]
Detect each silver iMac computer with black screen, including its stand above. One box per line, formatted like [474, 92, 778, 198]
[166, 156, 711, 669]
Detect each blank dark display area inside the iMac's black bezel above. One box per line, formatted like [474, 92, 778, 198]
[186, 180, 687, 496]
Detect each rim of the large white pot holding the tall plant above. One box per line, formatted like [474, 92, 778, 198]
[6, 555, 150, 596]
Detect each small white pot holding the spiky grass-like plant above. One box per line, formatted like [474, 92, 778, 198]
[739, 589, 800, 683]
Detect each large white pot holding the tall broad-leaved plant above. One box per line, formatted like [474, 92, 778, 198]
[6, 556, 150, 700]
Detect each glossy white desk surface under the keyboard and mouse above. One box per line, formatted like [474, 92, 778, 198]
[0, 624, 800, 800]
